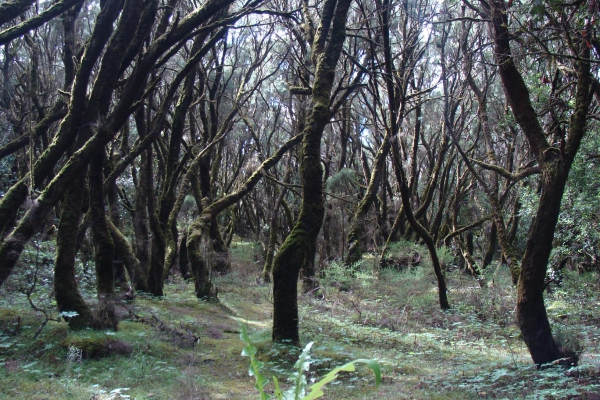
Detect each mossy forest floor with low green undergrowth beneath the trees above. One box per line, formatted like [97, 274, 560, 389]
[0, 239, 600, 400]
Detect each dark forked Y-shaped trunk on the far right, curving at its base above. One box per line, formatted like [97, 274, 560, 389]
[485, 0, 592, 365]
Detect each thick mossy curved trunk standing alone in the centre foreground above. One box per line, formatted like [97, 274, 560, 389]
[273, 0, 351, 344]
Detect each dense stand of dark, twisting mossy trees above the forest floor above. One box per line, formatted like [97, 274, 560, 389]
[0, 0, 600, 398]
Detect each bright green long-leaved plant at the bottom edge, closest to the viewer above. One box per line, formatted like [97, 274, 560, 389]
[240, 324, 381, 400]
